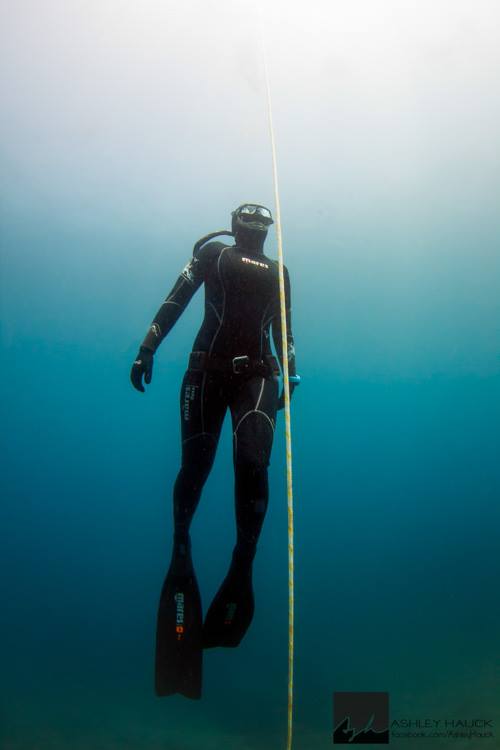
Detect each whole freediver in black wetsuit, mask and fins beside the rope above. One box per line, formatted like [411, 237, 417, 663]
[130, 203, 300, 698]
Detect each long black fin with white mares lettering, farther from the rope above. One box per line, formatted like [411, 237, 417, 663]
[155, 543, 203, 699]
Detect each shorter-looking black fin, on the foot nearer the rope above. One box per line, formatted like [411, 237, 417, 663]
[203, 557, 255, 648]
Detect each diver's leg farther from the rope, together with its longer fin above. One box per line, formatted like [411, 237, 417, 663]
[156, 370, 226, 698]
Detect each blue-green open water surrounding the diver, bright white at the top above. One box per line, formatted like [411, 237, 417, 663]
[0, 0, 500, 750]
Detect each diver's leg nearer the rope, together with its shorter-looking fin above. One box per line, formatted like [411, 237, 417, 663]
[203, 377, 278, 648]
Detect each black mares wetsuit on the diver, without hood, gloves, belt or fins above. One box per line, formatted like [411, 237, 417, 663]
[143, 242, 295, 565]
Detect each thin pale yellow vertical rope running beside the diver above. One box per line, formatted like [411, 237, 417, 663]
[260, 14, 294, 750]
